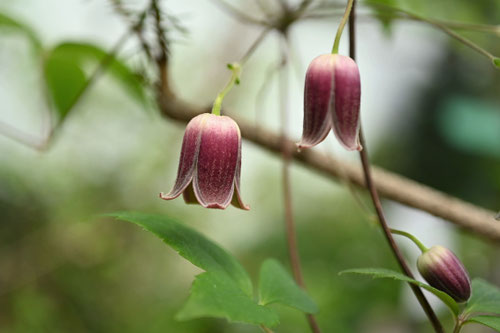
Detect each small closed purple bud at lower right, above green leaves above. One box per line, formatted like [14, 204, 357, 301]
[417, 245, 471, 302]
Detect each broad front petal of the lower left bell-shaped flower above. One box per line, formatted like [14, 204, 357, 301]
[193, 115, 240, 209]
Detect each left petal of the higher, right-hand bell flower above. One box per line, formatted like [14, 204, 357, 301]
[298, 54, 335, 149]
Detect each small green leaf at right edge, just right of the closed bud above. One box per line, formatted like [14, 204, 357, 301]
[464, 278, 500, 314]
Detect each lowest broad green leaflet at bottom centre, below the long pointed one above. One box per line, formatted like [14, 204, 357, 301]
[176, 272, 279, 327]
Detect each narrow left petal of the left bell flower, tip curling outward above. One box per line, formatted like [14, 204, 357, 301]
[160, 113, 208, 200]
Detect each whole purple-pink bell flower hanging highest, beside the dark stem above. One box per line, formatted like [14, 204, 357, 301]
[298, 54, 362, 150]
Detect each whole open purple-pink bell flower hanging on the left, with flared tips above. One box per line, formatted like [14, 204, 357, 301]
[160, 113, 250, 210]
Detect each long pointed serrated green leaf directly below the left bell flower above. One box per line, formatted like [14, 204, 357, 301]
[106, 212, 253, 297]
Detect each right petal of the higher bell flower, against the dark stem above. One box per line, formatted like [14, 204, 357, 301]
[331, 55, 362, 150]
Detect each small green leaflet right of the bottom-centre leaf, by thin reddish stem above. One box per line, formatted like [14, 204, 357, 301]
[259, 259, 318, 313]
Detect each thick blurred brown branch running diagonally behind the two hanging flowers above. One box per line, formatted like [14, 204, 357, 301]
[157, 91, 500, 242]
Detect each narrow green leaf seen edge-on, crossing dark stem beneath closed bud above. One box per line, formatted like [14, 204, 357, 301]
[339, 268, 459, 315]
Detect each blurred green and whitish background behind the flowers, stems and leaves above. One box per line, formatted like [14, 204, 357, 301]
[0, 0, 500, 333]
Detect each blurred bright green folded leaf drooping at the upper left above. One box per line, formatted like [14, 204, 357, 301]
[45, 42, 145, 121]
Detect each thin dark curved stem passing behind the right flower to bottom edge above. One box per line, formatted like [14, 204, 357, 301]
[349, 4, 444, 333]
